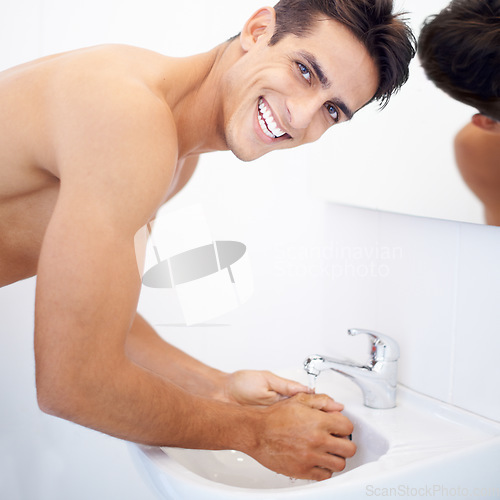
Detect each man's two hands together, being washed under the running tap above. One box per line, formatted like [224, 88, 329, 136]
[219, 370, 356, 481]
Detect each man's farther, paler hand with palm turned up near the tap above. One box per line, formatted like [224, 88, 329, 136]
[224, 370, 318, 409]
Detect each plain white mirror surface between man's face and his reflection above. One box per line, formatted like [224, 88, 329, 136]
[311, 0, 490, 224]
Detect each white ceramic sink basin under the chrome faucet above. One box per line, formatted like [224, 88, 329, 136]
[133, 370, 500, 500]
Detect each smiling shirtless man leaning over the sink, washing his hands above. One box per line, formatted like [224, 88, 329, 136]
[0, 0, 415, 480]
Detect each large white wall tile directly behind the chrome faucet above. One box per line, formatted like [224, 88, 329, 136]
[321, 205, 458, 401]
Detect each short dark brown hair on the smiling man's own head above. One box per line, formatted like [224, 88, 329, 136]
[269, 0, 416, 108]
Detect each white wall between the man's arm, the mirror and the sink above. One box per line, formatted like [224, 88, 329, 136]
[149, 171, 500, 421]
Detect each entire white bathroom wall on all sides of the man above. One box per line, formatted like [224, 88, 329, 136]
[0, 0, 500, 500]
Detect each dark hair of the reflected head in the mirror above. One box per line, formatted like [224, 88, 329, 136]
[418, 0, 500, 120]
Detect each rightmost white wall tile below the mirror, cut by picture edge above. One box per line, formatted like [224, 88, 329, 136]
[453, 224, 500, 421]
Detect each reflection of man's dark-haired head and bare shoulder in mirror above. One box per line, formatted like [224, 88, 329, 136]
[418, 0, 500, 226]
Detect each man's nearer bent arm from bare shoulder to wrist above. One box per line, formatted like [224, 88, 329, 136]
[35, 75, 237, 447]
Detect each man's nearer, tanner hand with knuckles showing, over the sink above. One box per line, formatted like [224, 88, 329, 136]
[249, 393, 356, 481]
